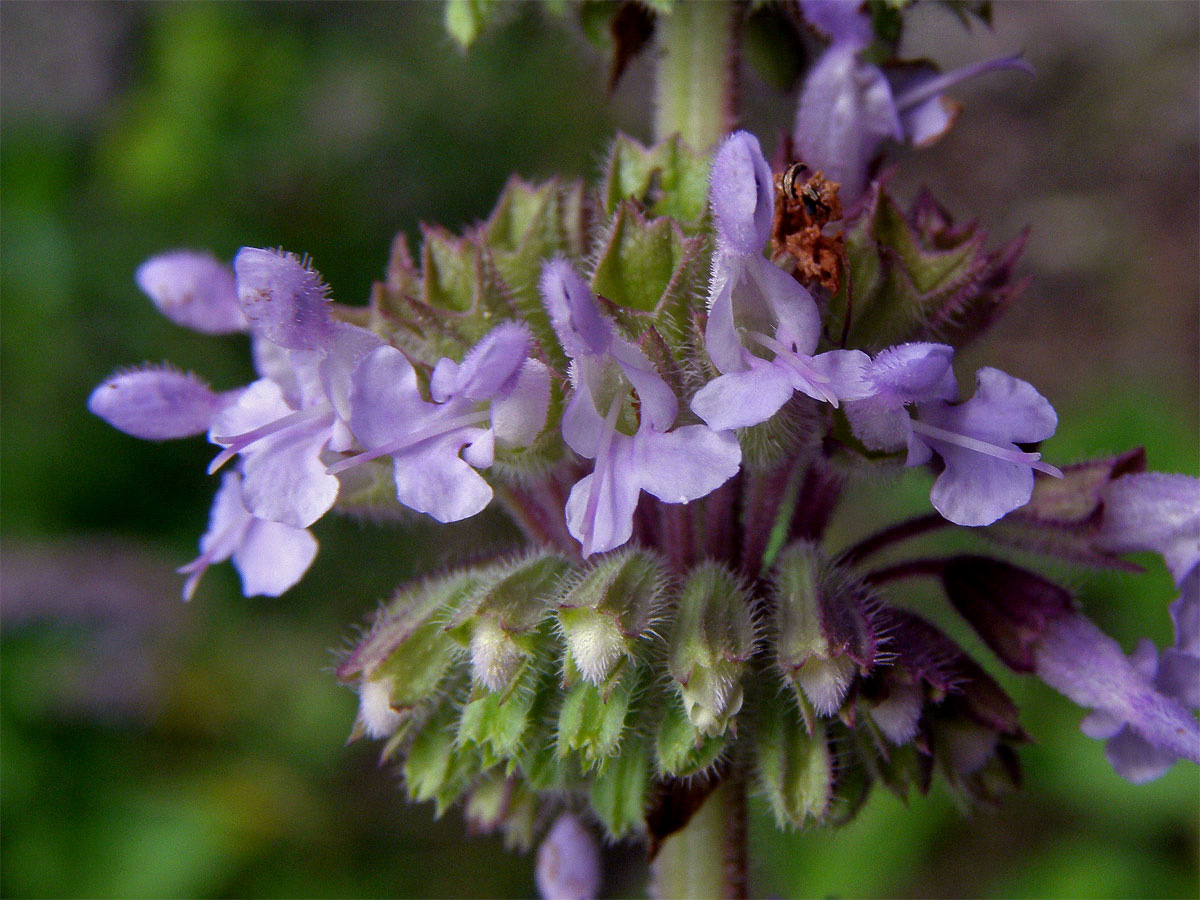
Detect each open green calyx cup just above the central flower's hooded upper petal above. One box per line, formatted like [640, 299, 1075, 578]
[592, 200, 708, 340]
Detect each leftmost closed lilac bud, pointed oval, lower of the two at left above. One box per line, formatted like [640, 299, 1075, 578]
[88, 365, 239, 440]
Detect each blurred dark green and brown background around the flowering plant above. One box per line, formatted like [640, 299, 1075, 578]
[0, 0, 1200, 898]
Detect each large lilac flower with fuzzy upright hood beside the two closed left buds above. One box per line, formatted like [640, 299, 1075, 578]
[209, 247, 382, 528]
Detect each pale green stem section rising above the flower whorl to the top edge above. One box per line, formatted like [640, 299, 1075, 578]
[654, 0, 739, 151]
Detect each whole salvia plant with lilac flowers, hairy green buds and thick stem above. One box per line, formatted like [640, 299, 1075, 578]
[90, 0, 1200, 898]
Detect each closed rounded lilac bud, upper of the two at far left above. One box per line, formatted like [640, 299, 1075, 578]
[134, 250, 247, 335]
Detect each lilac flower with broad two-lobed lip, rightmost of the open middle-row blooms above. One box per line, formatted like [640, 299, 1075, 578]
[846, 343, 1062, 526]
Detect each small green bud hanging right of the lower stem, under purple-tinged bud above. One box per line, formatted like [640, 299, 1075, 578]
[754, 701, 833, 828]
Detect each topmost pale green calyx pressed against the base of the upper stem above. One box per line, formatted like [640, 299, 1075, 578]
[600, 134, 709, 225]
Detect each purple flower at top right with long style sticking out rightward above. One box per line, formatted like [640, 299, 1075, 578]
[793, 0, 1032, 204]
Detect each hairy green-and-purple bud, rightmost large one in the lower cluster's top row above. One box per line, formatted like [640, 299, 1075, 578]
[773, 542, 876, 715]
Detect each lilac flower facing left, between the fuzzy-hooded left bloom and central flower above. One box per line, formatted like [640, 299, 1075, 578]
[328, 323, 550, 522]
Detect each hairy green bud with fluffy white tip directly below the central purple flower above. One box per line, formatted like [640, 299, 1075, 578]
[558, 551, 667, 684]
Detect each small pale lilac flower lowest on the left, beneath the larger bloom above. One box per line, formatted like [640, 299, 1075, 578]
[179, 472, 317, 600]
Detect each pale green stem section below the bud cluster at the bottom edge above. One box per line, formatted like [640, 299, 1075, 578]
[650, 774, 748, 900]
